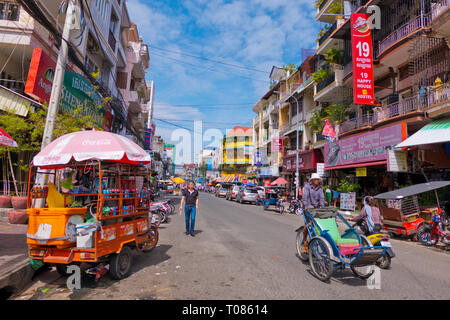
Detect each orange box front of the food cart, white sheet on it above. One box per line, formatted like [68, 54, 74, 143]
[27, 208, 87, 249]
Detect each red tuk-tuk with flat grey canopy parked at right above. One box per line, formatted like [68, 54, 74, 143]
[374, 181, 450, 238]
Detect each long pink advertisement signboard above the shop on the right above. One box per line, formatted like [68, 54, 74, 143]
[325, 124, 406, 168]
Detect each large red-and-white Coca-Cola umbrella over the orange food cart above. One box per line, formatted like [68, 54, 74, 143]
[33, 131, 151, 167]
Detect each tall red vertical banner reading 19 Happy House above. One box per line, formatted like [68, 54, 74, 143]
[351, 13, 375, 105]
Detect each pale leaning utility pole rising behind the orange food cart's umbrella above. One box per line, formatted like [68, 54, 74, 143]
[35, 0, 77, 208]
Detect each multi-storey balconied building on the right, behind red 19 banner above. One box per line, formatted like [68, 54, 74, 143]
[314, 0, 450, 193]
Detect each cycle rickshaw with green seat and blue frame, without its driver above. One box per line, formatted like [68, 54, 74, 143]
[296, 208, 388, 282]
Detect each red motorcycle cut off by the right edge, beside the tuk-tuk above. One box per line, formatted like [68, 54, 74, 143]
[417, 209, 450, 247]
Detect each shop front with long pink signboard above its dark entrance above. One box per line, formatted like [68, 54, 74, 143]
[325, 123, 408, 202]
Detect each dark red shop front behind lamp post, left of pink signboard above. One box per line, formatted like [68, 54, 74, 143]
[282, 150, 323, 192]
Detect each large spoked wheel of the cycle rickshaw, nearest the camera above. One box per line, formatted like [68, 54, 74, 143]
[308, 238, 333, 282]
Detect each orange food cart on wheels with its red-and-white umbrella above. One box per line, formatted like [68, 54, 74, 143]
[27, 131, 158, 279]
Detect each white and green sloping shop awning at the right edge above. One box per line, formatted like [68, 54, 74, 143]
[395, 117, 450, 148]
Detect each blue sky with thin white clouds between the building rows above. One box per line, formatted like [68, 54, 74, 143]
[127, 0, 319, 160]
